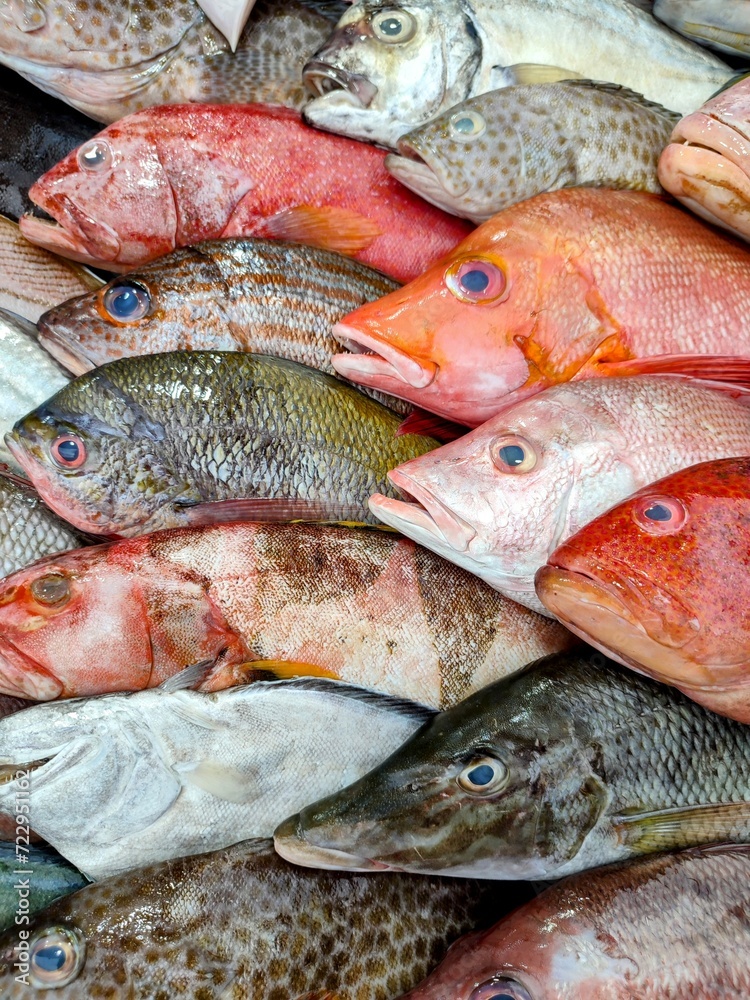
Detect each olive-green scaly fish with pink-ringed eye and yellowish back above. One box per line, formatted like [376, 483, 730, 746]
[6, 351, 438, 536]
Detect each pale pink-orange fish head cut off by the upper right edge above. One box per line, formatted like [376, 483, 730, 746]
[659, 76, 750, 240]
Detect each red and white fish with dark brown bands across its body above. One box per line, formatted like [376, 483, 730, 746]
[0, 524, 572, 708]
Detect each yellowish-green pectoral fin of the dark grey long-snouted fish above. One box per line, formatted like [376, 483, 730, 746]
[613, 802, 750, 854]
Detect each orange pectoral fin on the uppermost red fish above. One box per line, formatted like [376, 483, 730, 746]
[263, 205, 383, 254]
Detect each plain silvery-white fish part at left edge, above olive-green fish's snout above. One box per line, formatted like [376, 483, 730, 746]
[0, 309, 70, 472]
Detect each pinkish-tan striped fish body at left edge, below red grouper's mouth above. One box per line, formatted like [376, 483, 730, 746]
[0, 215, 104, 323]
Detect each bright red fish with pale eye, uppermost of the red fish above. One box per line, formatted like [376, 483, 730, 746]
[20, 104, 470, 281]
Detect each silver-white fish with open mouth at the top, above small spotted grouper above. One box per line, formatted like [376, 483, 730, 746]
[303, 0, 735, 149]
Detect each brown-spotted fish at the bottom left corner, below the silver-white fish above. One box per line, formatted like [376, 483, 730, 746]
[0, 841, 528, 1000]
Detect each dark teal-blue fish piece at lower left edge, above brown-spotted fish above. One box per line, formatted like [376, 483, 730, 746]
[0, 844, 89, 933]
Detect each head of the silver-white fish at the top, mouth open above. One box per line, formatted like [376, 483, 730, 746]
[303, 0, 482, 149]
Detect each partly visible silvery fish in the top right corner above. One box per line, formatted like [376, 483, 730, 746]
[653, 0, 750, 56]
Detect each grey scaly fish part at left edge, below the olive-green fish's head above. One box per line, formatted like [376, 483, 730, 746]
[0, 473, 86, 580]
